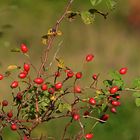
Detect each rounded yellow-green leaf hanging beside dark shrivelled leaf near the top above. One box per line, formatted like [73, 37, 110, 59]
[81, 11, 95, 24]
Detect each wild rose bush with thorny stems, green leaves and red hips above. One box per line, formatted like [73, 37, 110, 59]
[0, 0, 140, 140]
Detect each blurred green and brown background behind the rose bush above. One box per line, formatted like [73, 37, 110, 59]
[0, 0, 140, 140]
